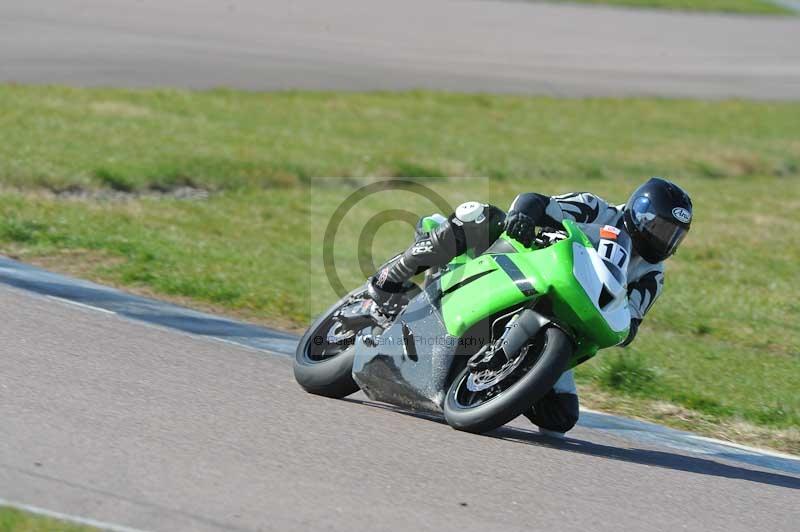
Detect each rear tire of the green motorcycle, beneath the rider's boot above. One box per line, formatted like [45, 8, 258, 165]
[294, 286, 366, 399]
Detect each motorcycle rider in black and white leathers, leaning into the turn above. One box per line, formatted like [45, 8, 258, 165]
[370, 177, 692, 437]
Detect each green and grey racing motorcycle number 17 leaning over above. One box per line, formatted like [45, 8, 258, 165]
[294, 218, 631, 433]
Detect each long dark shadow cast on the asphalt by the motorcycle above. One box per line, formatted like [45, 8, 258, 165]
[344, 398, 800, 489]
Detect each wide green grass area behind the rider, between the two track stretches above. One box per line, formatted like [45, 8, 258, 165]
[0, 86, 800, 451]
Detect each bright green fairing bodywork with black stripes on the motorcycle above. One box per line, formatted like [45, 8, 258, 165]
[440, 221, 627, 367]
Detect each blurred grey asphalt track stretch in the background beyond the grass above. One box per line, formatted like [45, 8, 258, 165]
[0, 0, 800, 99]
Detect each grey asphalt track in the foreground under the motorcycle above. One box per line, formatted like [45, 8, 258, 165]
[0, 260, 800, 532]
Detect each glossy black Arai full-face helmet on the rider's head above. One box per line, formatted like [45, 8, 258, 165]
[624, 177, 692, 264]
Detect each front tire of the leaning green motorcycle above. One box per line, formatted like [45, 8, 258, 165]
[444, 326, 573, 433]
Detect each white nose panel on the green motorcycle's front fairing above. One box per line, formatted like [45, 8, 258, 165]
[572, 244, 631, 333]
